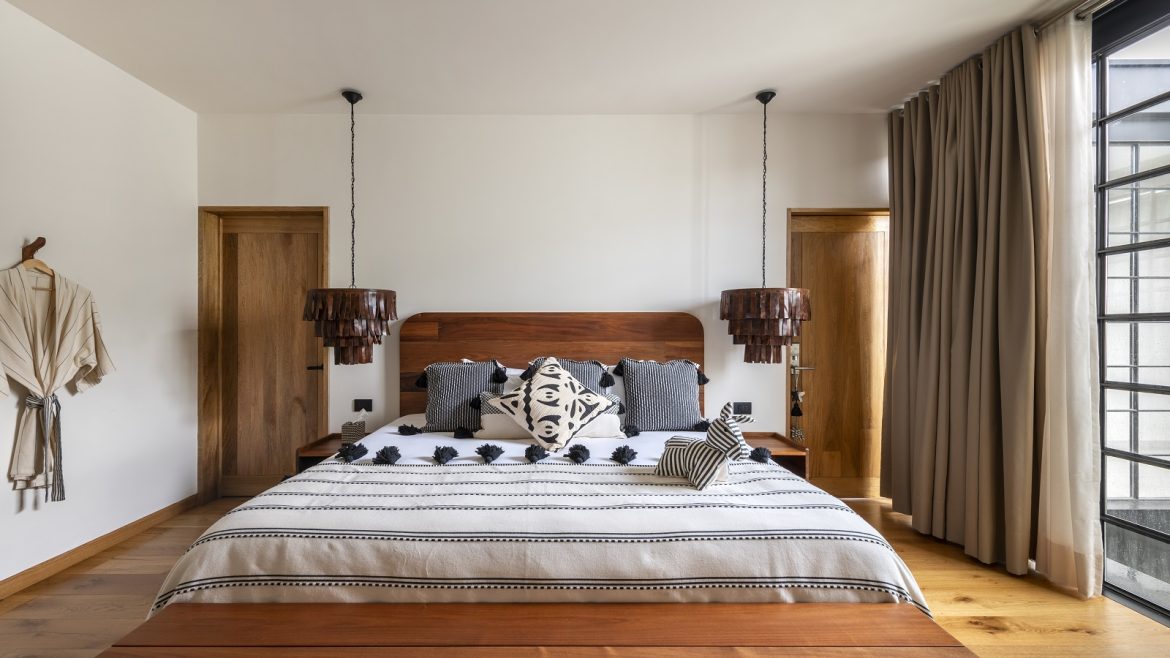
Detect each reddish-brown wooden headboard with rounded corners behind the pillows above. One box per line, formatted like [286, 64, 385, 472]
[399, 313, 703, 416]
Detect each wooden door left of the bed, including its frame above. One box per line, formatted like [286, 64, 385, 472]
[200, 208, 328, 498]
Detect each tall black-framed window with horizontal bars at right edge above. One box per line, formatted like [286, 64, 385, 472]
[1093, 0, 1170, 615]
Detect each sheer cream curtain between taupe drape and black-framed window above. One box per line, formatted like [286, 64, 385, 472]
[1035, 15, 1102, 597]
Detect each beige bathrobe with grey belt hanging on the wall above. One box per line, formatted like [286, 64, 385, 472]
[0, 266, 113, 500]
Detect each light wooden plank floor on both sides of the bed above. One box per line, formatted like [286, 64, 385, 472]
[0, 499, 1170, 658]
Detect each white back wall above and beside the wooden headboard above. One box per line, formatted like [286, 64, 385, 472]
[199, 111, 887, 430]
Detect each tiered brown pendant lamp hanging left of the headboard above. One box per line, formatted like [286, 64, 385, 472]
[304, 89, 398, 365]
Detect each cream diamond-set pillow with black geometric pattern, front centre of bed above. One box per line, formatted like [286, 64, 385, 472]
[490, 357, 618, 452]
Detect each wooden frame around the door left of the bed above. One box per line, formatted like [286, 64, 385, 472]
[195, 206, 329, 503]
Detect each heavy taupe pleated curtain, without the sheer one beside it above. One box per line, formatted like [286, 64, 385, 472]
[882, 27, 1049, 574]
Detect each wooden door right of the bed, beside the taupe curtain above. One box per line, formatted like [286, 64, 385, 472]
[789, 210, 889, 496]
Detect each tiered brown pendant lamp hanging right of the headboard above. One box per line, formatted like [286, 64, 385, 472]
[720, 90, 812, 363]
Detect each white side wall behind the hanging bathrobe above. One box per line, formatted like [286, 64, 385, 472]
[0, 1, 198, 578]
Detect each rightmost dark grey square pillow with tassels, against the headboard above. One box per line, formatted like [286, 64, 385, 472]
[614, 358, 707, 432]
